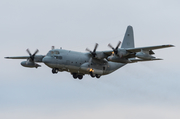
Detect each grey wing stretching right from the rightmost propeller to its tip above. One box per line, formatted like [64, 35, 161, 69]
[126, 45, 174, 52]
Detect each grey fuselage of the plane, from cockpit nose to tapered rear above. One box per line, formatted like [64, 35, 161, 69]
[42, 49, 125, 75]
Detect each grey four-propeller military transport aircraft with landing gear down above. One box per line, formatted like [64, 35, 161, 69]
[5, 26, 173, 79]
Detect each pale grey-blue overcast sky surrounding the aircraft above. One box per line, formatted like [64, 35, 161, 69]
[0, 0, 180, 119]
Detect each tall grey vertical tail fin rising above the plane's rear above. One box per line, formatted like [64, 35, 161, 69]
[121, 26, 134, 48]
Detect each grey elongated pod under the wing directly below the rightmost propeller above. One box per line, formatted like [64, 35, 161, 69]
[107, 55, 131, 63]
